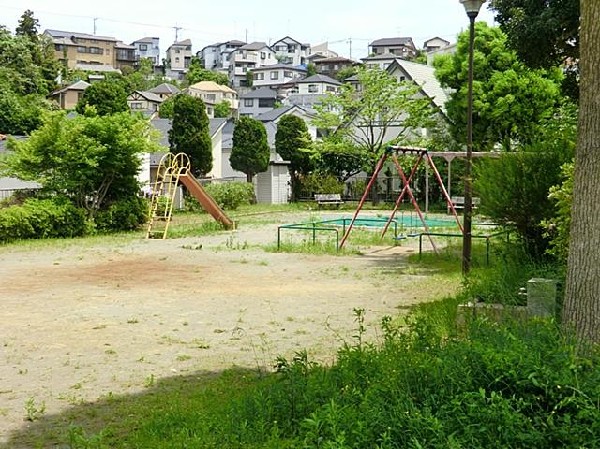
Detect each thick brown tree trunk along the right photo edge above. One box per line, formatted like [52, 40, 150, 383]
[563, 0, 600, 343]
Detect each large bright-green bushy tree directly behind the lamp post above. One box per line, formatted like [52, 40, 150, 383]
[434, 22, 562, 151]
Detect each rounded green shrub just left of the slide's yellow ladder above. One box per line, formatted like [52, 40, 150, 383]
[94, 196, 148, 232]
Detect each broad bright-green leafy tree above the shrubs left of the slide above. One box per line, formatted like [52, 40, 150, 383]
[4, 113, 158, 218]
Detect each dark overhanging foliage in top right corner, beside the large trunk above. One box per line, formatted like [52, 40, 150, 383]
[490, 0, 579, 97]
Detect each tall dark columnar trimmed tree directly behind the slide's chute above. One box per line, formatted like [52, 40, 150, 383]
[169, 94, 213, 175]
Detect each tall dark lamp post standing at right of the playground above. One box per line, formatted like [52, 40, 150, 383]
[459, 0, 485, 275]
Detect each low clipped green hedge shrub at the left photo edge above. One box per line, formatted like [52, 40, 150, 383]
[0, 198, 86, 242]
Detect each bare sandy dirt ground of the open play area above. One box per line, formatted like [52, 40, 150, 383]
[0, 212, 447, 443]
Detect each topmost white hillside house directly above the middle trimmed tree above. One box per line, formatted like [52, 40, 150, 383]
[229, 42, 277, 88]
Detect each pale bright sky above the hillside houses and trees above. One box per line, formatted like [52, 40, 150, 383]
[0, 0, 493, 60]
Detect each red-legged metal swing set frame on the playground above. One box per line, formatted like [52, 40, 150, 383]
[339, 145, 464, 250]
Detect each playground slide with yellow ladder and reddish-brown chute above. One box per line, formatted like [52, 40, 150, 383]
[146, 153, 234, 239]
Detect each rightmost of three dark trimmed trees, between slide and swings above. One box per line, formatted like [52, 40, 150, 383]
[275, 114, 313, 200]
